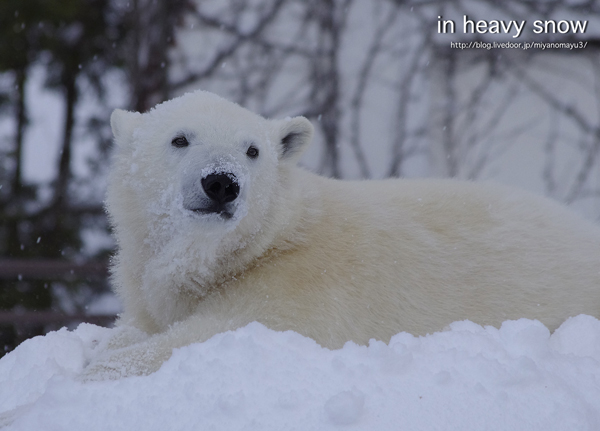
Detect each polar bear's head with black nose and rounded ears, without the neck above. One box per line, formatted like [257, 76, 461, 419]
[111, 91, 313, 229]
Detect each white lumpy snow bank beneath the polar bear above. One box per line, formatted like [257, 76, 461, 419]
[0, 315, 600, 431]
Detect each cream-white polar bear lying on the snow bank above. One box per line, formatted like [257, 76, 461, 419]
[86, 91, 600, 377]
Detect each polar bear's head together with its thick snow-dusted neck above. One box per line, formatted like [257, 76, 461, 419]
[107, 91, 313, 328]
